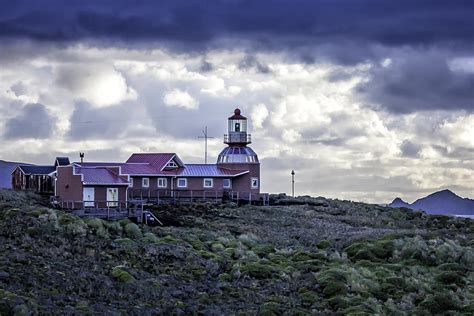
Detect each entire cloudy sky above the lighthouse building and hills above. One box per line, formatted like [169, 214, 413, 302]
[0, 0, 474, 203]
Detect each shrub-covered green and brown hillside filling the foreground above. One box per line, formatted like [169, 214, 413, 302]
[0, 191, 474, 315]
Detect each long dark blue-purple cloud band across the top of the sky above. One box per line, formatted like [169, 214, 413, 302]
[0, 0, 474, 49]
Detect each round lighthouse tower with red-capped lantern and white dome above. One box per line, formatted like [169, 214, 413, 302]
[217, 108, 260, 195]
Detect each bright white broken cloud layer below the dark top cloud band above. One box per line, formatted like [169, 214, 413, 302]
[0, 43, 474, 202]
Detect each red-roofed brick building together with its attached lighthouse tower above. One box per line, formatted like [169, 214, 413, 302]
[54, 109, 260, 208]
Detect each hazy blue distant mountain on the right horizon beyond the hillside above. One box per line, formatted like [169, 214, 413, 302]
[388, 190, 474, 215]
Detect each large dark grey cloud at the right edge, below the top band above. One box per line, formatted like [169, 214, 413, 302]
[358, 52, 474, 113]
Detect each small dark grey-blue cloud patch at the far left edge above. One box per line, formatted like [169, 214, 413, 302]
[4, 103, 56, 139]
